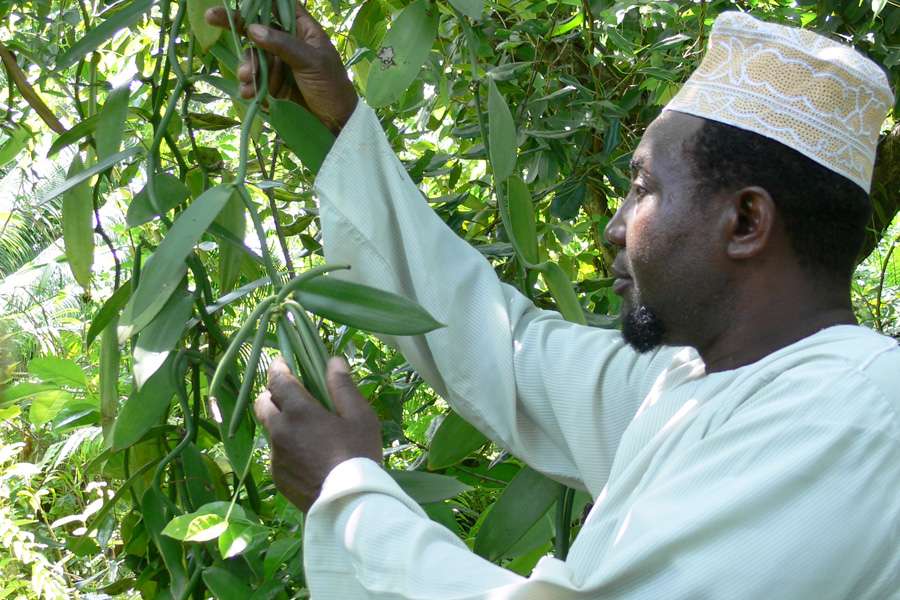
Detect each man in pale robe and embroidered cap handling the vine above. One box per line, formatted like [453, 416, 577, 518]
[209, 5, 900, 600]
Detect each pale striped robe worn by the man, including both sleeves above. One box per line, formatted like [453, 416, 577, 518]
[304, 102, 900, 600]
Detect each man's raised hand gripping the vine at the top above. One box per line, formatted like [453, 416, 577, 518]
[206, 2, 357, 133]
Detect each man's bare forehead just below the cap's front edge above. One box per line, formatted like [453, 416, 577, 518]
[632, 110, 705, 178]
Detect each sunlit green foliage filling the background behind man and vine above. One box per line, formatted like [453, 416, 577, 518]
[0, 0, 900, 598]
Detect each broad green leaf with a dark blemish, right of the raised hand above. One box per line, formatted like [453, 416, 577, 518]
[366, 0, 438, 108]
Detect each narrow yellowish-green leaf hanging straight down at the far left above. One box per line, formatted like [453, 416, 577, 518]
[62, 154, 94, 290]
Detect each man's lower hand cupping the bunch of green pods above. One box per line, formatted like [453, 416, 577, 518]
[254, 358, 382, 511]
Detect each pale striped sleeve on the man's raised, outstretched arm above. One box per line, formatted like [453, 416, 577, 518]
[316, 100, 672, 495]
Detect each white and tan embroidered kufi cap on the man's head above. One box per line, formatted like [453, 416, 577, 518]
[664, 12, 894, 193]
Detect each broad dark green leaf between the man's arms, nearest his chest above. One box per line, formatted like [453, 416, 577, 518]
[474, 467, 560, 560]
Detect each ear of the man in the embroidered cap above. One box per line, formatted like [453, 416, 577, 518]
[725, 186, 776, 260]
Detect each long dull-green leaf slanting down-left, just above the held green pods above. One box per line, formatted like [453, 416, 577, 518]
[119, 184, 233, 342]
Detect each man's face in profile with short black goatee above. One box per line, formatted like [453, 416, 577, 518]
[606, 112, 728, 352]
